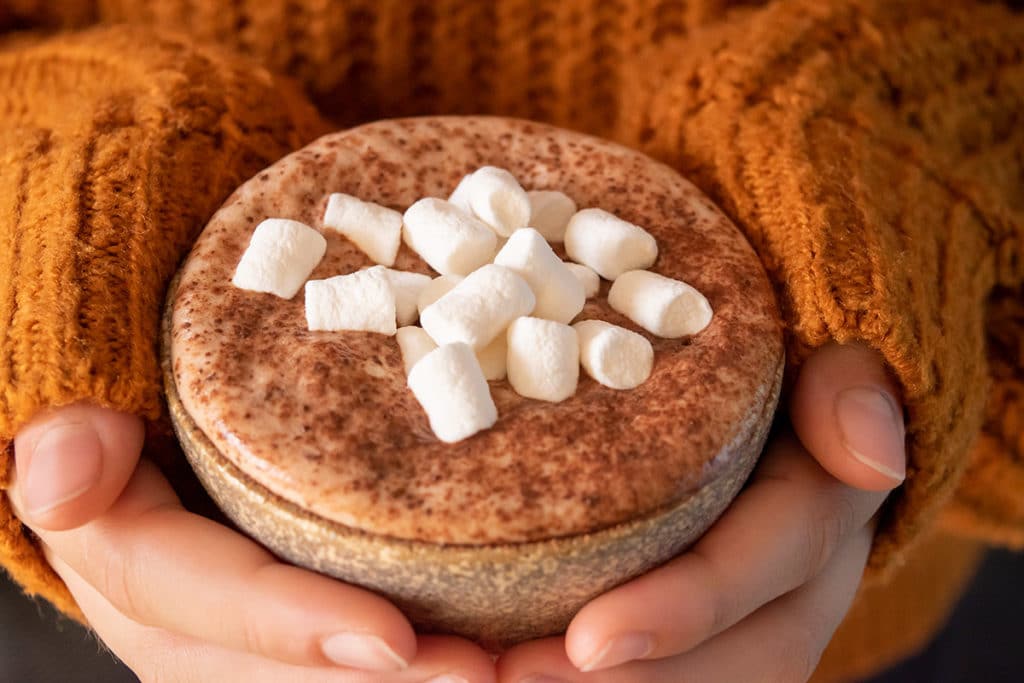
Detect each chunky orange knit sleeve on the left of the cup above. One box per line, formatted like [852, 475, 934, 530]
[0, 28, 321, 614]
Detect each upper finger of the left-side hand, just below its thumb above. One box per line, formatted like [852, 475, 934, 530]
[12, 461, 416, 671]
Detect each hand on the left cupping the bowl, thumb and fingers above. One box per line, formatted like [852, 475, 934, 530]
[8, 404, 495, 683]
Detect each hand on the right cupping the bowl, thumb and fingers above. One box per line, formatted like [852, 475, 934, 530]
[498, 345, 905, 683]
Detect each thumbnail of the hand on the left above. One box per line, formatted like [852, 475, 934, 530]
[23, 423, 103, 517]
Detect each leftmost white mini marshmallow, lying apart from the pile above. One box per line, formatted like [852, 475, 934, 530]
[231, 218, 327, 299]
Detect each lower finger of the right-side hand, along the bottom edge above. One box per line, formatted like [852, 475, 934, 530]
[498, 527, 871, 683]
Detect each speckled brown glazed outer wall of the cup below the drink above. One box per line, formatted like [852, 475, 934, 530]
[165, 339, 781, 651]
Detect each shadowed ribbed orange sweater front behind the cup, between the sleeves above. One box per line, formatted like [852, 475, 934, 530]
[6, 0, 745, 136]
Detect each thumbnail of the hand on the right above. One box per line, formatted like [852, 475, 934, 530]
[836, 387, 906, 483]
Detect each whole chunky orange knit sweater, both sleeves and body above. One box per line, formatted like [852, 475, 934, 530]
[0, 0, 1024, 679]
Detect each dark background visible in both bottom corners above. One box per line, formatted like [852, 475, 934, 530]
[0, 551, 1024, 683]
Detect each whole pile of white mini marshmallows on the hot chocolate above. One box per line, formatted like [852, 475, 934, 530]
[232, 166, 712, 442]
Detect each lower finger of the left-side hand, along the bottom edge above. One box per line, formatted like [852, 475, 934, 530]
[48, 554, 495, 683]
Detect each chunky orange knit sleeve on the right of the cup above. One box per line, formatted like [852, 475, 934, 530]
[620, 0, 1024, 574]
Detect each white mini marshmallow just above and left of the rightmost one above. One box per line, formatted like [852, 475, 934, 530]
[565, 209, 657, 280]
